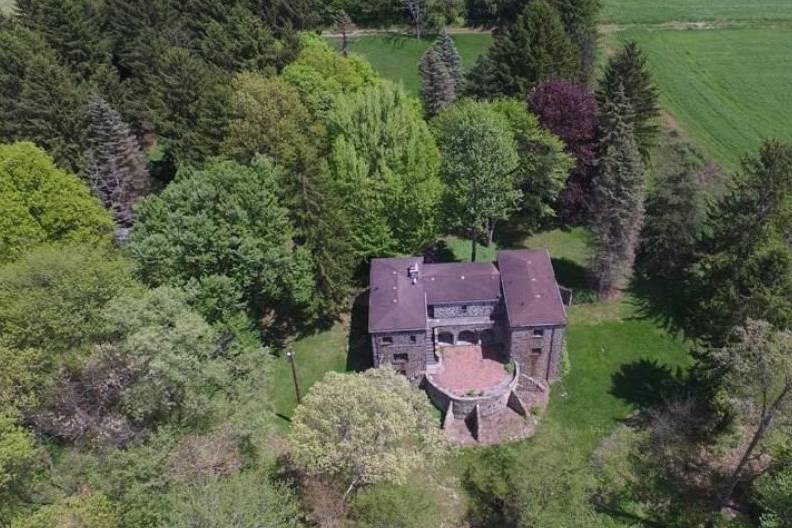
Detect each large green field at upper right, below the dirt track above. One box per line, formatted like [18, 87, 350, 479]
[618, 26, 792, 169]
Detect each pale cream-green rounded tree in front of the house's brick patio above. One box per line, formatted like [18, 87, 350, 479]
[290, 369, 442, 494]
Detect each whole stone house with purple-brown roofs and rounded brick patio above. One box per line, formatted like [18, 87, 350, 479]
[368, 250, 566, 439]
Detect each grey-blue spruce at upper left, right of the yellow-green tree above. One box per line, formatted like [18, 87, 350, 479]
[86, 95, 150, 239]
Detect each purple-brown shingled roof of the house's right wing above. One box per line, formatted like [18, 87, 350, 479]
[497, 249, 566, 327]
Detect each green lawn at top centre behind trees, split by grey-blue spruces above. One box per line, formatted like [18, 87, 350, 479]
[334, 33, 492, 94]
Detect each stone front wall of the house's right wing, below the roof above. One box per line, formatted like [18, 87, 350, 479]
[506, 327, 564, 381]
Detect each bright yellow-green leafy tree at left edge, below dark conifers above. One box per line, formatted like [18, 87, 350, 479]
[0, 142, 113, 263]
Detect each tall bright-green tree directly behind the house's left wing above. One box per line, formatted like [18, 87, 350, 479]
[328, 82, 442, 257]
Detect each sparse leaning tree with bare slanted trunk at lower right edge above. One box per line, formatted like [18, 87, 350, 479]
[714, 319, 792, 503]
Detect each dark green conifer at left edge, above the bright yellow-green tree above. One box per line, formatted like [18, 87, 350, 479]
[0, 24, 86, 171]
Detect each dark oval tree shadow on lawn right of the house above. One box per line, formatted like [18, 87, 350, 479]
[609, 359, 687, 410]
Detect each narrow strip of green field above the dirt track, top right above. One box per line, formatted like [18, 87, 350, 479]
[601, 0, 792, 24]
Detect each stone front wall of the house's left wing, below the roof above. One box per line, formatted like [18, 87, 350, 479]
[371, 330, 432, 379]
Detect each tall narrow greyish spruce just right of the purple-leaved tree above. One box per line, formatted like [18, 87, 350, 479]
[592, 84, 644, 297]
